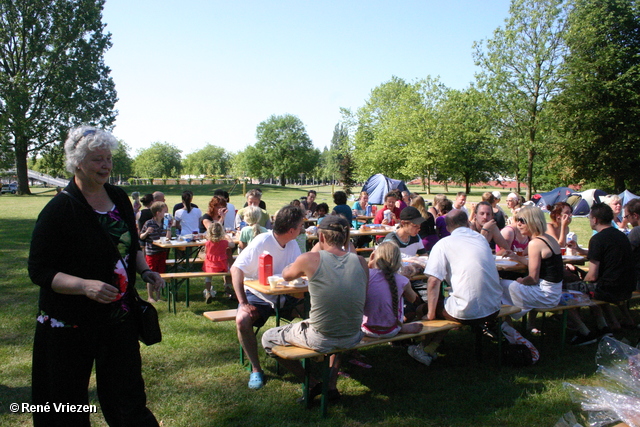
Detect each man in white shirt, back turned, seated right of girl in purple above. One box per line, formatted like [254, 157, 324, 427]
[409, 210, 502, 365]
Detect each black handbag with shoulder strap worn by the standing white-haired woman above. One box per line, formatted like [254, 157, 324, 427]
[62, 190, 162, 345]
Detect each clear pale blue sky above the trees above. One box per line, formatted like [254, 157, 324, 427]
[103, 0, 509, 156]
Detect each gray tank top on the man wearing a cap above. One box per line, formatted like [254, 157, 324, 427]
[309, 251, 367, 338]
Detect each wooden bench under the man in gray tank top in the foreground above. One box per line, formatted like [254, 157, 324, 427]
[271, 306, 520, 417]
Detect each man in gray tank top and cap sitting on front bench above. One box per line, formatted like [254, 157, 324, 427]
[262, 215, 369, 403]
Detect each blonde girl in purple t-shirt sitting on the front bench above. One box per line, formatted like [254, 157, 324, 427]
[362, 242, 422, 338]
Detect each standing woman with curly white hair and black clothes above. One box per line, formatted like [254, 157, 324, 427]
[29, 126, 164, 426]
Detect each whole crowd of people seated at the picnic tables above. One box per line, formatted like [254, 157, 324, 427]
[127, 190, 640, 400]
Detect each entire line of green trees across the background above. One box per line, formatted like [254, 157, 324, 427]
[0, 0, 640, 198]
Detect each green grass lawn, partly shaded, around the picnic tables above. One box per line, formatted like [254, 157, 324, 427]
[0, 185, 640, 427]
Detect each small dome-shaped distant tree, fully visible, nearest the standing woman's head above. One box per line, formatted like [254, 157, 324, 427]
[133, 142, 182, 178]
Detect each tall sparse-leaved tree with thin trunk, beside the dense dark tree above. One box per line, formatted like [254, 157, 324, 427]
[474, 0, 566, 198]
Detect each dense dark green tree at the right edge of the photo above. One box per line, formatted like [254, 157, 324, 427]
[554, 0, 640, 192]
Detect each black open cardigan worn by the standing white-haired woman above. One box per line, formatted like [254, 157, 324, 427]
[29, 178, 140, 326]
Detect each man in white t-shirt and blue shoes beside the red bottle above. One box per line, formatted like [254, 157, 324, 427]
[231, 206, 304, 389]
